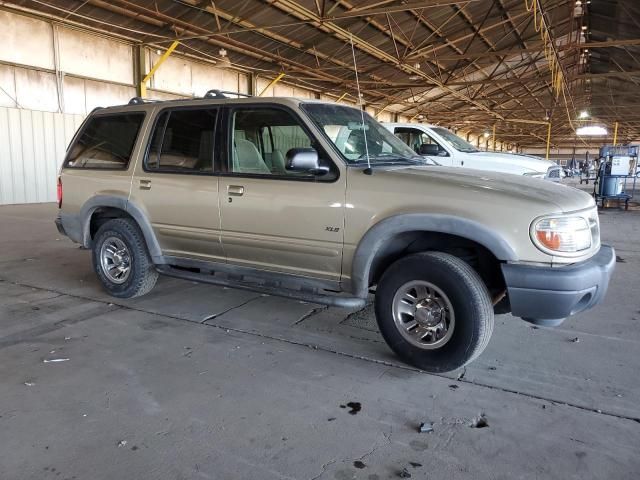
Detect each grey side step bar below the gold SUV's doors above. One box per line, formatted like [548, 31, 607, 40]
[156, 265, 367, 308]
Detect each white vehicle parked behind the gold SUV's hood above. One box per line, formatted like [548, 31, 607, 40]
[384, 123, 562, 182]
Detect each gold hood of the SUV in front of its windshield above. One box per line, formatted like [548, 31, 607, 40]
[374, 166, 594, 212]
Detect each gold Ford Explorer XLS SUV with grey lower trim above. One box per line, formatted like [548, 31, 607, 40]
[56, 90, 615, 372]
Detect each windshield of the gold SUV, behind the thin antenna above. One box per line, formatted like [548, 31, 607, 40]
[302, 103, 422, 165]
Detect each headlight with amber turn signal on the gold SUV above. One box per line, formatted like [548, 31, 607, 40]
[531, 216, 597, 254]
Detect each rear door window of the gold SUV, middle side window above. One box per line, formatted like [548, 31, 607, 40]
[145, 108, 217, 173]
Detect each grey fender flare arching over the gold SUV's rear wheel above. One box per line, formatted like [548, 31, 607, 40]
[80, 195, 165, 263]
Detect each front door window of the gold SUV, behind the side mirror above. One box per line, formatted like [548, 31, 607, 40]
[229, 108, 322, 178]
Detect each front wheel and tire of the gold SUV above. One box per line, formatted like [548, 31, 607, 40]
[375, 252, 494, 373]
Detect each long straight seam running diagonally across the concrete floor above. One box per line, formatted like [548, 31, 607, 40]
[5, 278, 640, 423]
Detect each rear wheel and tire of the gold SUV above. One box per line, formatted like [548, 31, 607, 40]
[91, 218, 158, 298]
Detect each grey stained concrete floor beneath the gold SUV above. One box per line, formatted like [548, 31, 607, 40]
[0, 200, 640, 480]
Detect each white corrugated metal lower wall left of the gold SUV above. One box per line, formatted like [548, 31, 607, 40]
[0, 107, 83, 205]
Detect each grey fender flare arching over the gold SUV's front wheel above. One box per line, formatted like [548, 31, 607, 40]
[351, 213, 517, 297]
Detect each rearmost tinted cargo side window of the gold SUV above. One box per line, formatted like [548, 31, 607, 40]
[65, 113, 144, 170]
